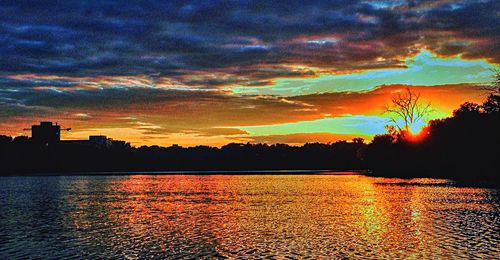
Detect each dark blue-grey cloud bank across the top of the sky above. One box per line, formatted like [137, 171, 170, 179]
[0, 0, 500, 76]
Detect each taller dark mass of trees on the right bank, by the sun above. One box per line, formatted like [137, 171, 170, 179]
[363, 88, 500, 183]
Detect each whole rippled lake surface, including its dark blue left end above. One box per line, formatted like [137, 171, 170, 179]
[0, 175, 500, 259]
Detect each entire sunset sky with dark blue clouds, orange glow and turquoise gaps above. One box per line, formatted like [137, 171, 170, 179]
[0, 0, 500, 146]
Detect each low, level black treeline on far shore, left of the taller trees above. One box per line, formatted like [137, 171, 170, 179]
[0, 136, 366, 174]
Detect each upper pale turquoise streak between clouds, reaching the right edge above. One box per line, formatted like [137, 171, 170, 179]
[232, 50, 500, 96]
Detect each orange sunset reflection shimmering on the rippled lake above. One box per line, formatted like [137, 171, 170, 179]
[63, 175, 499, 258]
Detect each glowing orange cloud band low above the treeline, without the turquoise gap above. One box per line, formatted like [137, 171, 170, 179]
[0, 84, 484, 145]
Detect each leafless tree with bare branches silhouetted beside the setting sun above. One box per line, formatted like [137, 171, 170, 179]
[385, 88, 432, 134]
